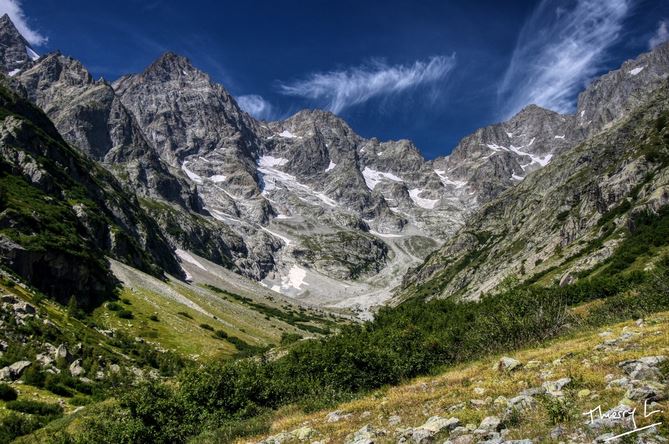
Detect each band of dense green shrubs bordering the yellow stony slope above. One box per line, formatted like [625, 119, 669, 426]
[11, 227, 669, 442]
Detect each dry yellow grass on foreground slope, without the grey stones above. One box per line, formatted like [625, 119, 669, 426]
[244, 312, 669, 444]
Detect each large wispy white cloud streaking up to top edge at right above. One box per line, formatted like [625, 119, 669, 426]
[498, 0, 632, 118]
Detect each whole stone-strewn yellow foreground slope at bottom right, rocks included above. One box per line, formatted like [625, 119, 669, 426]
[245, 306, 669, 444]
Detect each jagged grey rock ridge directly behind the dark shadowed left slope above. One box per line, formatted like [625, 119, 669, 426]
[16, 53, 200, 210]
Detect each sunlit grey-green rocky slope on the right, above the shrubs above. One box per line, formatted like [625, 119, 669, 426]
[400, 45, 669, 298]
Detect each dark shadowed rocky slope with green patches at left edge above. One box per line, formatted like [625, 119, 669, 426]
[0, 83, 180, 303]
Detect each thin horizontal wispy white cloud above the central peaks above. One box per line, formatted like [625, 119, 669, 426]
[279, 55, 455, 113]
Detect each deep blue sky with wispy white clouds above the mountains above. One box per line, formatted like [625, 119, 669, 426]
[5, 0, 669, 158]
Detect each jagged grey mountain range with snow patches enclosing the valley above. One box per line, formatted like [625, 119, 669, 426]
[0, 16, 669, 316]
